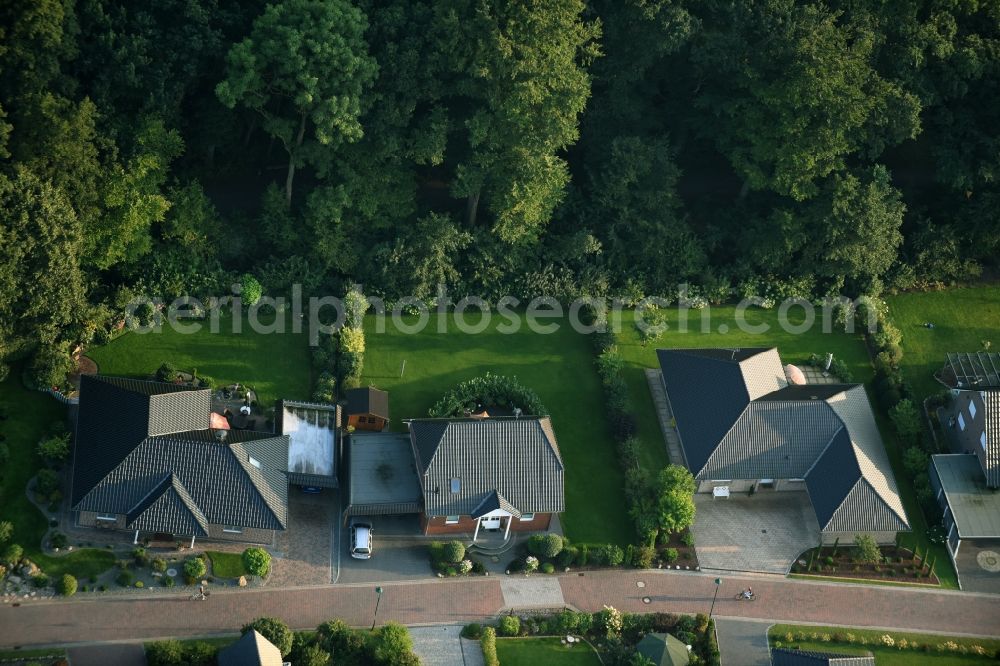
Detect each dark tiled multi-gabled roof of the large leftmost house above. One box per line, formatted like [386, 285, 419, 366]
[73, 377, 288, 536]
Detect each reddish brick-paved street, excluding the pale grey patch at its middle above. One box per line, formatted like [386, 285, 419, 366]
[0, 570, 1000, 647]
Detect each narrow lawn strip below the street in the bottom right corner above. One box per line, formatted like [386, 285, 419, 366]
[772, 624, 1000, 666]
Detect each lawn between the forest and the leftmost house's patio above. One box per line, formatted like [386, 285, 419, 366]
[87, 308, 312, 407]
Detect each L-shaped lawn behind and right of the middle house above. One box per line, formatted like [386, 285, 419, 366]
[362, 316, 635, 545]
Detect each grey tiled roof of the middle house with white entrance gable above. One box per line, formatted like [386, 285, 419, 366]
[409, 416, 565, 516]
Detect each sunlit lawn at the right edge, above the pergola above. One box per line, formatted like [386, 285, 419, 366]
[886, 285, 1000, 399]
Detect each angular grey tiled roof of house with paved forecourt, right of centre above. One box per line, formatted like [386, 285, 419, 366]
[657, 349, 909, 531]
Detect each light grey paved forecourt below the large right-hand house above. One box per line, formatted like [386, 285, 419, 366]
[692, 491, 819, 574]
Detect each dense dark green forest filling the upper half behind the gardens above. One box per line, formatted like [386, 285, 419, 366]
[0, 0, 1000, 385]
